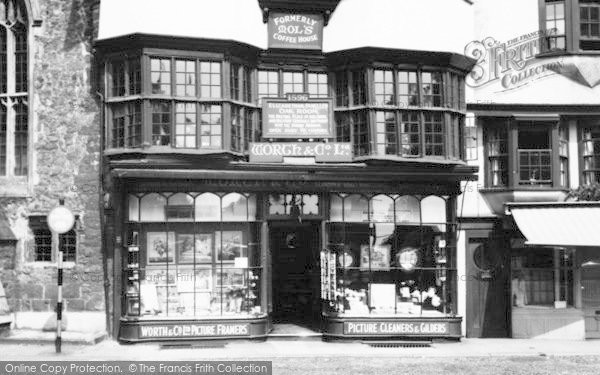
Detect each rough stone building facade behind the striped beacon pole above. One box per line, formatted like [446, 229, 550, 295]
[0, 0, 106, 329]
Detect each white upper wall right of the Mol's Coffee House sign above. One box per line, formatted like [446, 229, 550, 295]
[323, 0, 473, 53]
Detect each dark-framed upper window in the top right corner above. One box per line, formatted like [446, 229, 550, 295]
[538, 0, 600, 52]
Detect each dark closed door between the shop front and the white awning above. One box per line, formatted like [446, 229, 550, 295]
[459, 237, 510, 338]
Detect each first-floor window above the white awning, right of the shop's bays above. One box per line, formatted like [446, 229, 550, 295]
[479, 117, 569, 189]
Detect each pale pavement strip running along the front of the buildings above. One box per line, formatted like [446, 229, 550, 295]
[0, 338, 600, 363]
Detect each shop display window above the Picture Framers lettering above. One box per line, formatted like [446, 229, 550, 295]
[123, 192, 264, 318]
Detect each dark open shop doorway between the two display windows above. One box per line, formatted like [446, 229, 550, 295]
[270, 221, 321, 330]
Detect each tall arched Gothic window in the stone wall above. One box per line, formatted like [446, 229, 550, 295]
[0, 0, 30, 177]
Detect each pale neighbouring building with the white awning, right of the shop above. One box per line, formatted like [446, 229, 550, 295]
[459, 0, 600, 338]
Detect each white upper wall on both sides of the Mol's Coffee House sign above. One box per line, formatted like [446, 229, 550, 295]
[99, 0, 473, 53]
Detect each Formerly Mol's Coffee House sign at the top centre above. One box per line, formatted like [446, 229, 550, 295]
[268, 13, 324, 50]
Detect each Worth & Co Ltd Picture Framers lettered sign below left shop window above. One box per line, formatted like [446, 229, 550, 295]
[140, 323, 250, 338]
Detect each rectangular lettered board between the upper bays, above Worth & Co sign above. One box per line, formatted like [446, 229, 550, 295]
[262, 98, 333, 139]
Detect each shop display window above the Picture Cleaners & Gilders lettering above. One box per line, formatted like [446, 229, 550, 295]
[321, 194, 456, 317]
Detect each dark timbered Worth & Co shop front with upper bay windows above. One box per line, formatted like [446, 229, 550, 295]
[96, 2, 477, 342]
